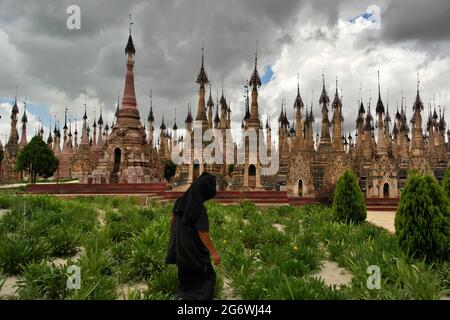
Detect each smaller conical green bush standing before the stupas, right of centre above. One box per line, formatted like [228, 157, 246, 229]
[333, 170, 367, 223]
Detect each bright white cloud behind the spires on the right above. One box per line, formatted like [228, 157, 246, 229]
[260, 14, 450, 140]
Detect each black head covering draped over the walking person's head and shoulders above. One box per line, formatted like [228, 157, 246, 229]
[173, 172, 216, 223]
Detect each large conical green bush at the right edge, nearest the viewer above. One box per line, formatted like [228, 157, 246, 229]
[395, 174, 450, 260]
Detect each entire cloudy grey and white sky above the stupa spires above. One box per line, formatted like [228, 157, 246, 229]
[0, 0, 450, 144]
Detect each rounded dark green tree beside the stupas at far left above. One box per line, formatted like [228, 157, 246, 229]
[16, 136, 59, 183]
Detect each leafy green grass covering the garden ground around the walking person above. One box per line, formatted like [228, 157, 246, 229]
[0, 192, 450, 300]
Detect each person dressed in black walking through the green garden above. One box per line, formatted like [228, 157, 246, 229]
[165, 172, 221, 300]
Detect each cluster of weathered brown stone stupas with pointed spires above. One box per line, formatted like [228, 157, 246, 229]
[0, 23, 450, 198]
